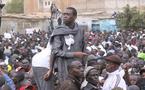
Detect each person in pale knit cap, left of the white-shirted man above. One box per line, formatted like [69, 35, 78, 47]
[82, 66, 101, 90]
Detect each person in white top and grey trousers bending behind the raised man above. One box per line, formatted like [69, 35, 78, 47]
[32, 47, 54, 90]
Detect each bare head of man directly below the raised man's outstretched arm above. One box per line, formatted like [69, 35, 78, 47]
[68, 61, 84, 78]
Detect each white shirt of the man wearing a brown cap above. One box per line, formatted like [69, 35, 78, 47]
[102, 69, 127, 90]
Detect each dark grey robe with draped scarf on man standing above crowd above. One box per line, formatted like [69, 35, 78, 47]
[50, 24, 86, 81]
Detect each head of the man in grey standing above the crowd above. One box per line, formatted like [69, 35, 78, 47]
[63, 7, 77, 25]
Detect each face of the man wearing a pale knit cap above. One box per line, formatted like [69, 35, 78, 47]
[87, 69, 99, 85]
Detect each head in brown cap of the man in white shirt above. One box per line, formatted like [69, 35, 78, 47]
[105, 55, 122, 73]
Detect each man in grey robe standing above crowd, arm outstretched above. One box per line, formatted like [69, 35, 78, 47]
[47, 7, 87, 81]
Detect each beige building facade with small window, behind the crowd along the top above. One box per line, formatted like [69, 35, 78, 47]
[24, 0, 145, 18]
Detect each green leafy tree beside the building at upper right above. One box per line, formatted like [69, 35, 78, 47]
[116, 5, 145, 30]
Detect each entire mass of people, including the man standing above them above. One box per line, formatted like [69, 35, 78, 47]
[0, 7, 145, 90]
